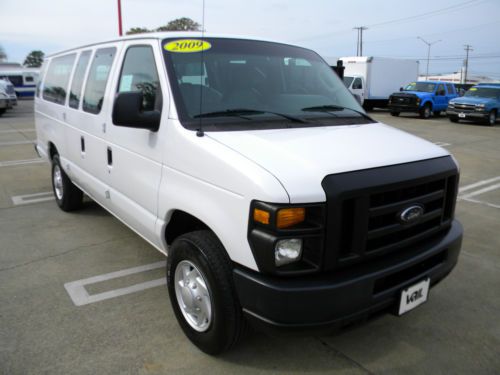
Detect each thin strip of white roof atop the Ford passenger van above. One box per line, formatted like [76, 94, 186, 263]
[45, 31, 289, 58]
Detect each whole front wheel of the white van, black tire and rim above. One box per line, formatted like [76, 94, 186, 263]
[167, 230, 244, 355]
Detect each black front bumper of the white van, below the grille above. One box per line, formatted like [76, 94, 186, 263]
[234, 221, 463, 333]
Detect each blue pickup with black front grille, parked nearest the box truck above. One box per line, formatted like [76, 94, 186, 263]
[389, 81, 458, 119]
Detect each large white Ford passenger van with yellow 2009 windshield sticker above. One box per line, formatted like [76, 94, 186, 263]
[35, 33, 462, 354]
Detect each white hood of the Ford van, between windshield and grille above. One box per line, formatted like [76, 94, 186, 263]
[205, 123, 449, 203]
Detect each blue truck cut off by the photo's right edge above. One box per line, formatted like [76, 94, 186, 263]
[446, 84, 500, 126]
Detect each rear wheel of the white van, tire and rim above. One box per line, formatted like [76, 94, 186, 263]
[52, 154, 83, 212]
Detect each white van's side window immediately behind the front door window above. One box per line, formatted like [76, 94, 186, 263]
[83, 47, 116, 114]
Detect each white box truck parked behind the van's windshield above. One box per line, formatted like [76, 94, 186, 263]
[340, 56, 418, 109]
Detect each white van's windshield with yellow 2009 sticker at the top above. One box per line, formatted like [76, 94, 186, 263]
[162, 38, 374, 131]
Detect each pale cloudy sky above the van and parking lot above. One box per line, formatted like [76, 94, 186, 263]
[0, 0, 500, 80]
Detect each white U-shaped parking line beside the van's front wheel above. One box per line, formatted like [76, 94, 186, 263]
[64, 261, 167, 306]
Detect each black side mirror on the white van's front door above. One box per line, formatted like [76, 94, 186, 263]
[112, 91, 161, 132]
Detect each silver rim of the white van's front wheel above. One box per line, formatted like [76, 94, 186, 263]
[174, 260, 212, 332]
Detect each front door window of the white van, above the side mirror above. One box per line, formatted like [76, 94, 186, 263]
[118, 46, 161, 111]
